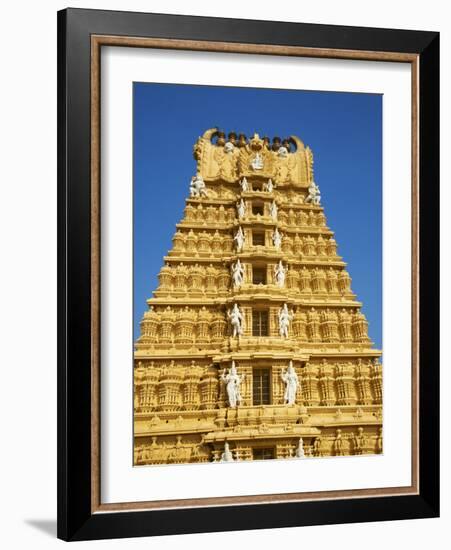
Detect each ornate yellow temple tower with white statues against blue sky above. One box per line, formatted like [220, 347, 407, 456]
[134, 129, 382, 465]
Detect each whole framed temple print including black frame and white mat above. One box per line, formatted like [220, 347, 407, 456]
[58, 9, 439, 540]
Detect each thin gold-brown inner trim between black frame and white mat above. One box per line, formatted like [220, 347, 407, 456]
[91, 35, 420, 513]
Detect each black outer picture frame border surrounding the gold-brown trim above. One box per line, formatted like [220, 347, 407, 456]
[58, 9, 439, 540]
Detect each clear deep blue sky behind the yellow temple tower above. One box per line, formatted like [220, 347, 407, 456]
[133, 83, 382, 349]
